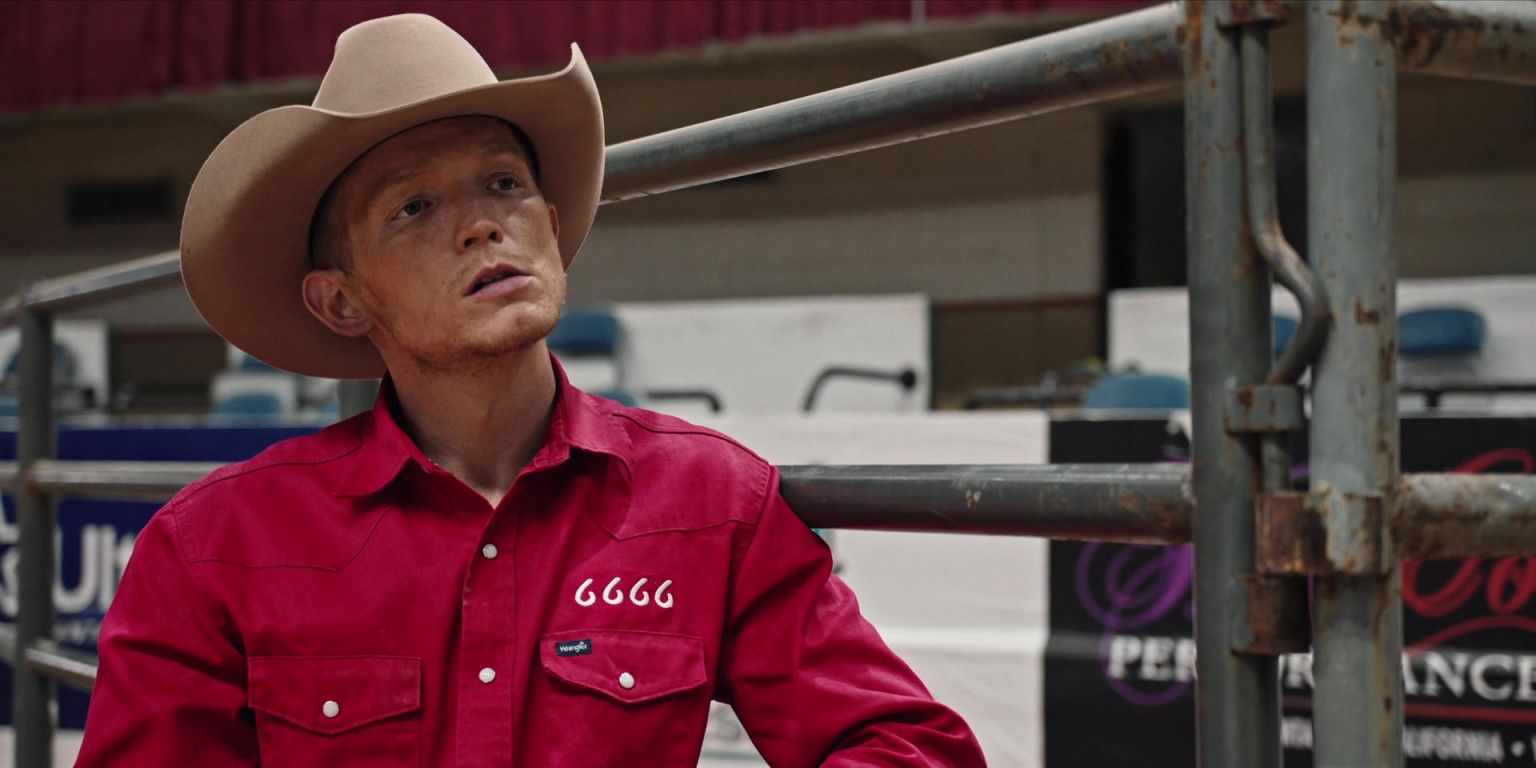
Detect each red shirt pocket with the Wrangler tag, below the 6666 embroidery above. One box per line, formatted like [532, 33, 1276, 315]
[530, 630, 710, 766]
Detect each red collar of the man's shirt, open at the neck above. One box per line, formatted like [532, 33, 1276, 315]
[335, 353, 630, 496]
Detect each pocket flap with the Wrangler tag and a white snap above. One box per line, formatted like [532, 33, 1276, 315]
[539, 630, 708, 703]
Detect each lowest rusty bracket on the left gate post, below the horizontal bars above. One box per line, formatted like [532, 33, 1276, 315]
[1227, 573, 1312, 656]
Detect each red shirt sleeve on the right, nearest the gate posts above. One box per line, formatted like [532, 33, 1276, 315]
[717, 470, 986, 768]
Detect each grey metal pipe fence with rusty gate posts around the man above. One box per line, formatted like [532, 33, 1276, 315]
[0, 0, 1536, 768]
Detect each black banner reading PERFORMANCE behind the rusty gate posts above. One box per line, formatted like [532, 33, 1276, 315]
[1044, 418, 1536, 768]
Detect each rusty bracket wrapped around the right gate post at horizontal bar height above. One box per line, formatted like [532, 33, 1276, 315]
[1253, 488, 1392, 576]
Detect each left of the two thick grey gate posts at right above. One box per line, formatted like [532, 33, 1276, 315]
[1184, 0, 1281, 768]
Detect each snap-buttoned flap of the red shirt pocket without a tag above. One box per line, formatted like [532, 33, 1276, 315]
[247, 656, 421, 734]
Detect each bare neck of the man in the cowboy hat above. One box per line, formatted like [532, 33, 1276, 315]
[390, 341, 556, 507]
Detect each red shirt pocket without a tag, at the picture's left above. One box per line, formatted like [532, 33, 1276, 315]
[247, 656, 421, 768]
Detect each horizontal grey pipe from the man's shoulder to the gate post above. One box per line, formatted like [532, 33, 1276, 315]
[779, 464, 1193, 542]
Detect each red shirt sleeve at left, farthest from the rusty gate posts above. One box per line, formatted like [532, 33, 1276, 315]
[75, 508, 258, 768]
